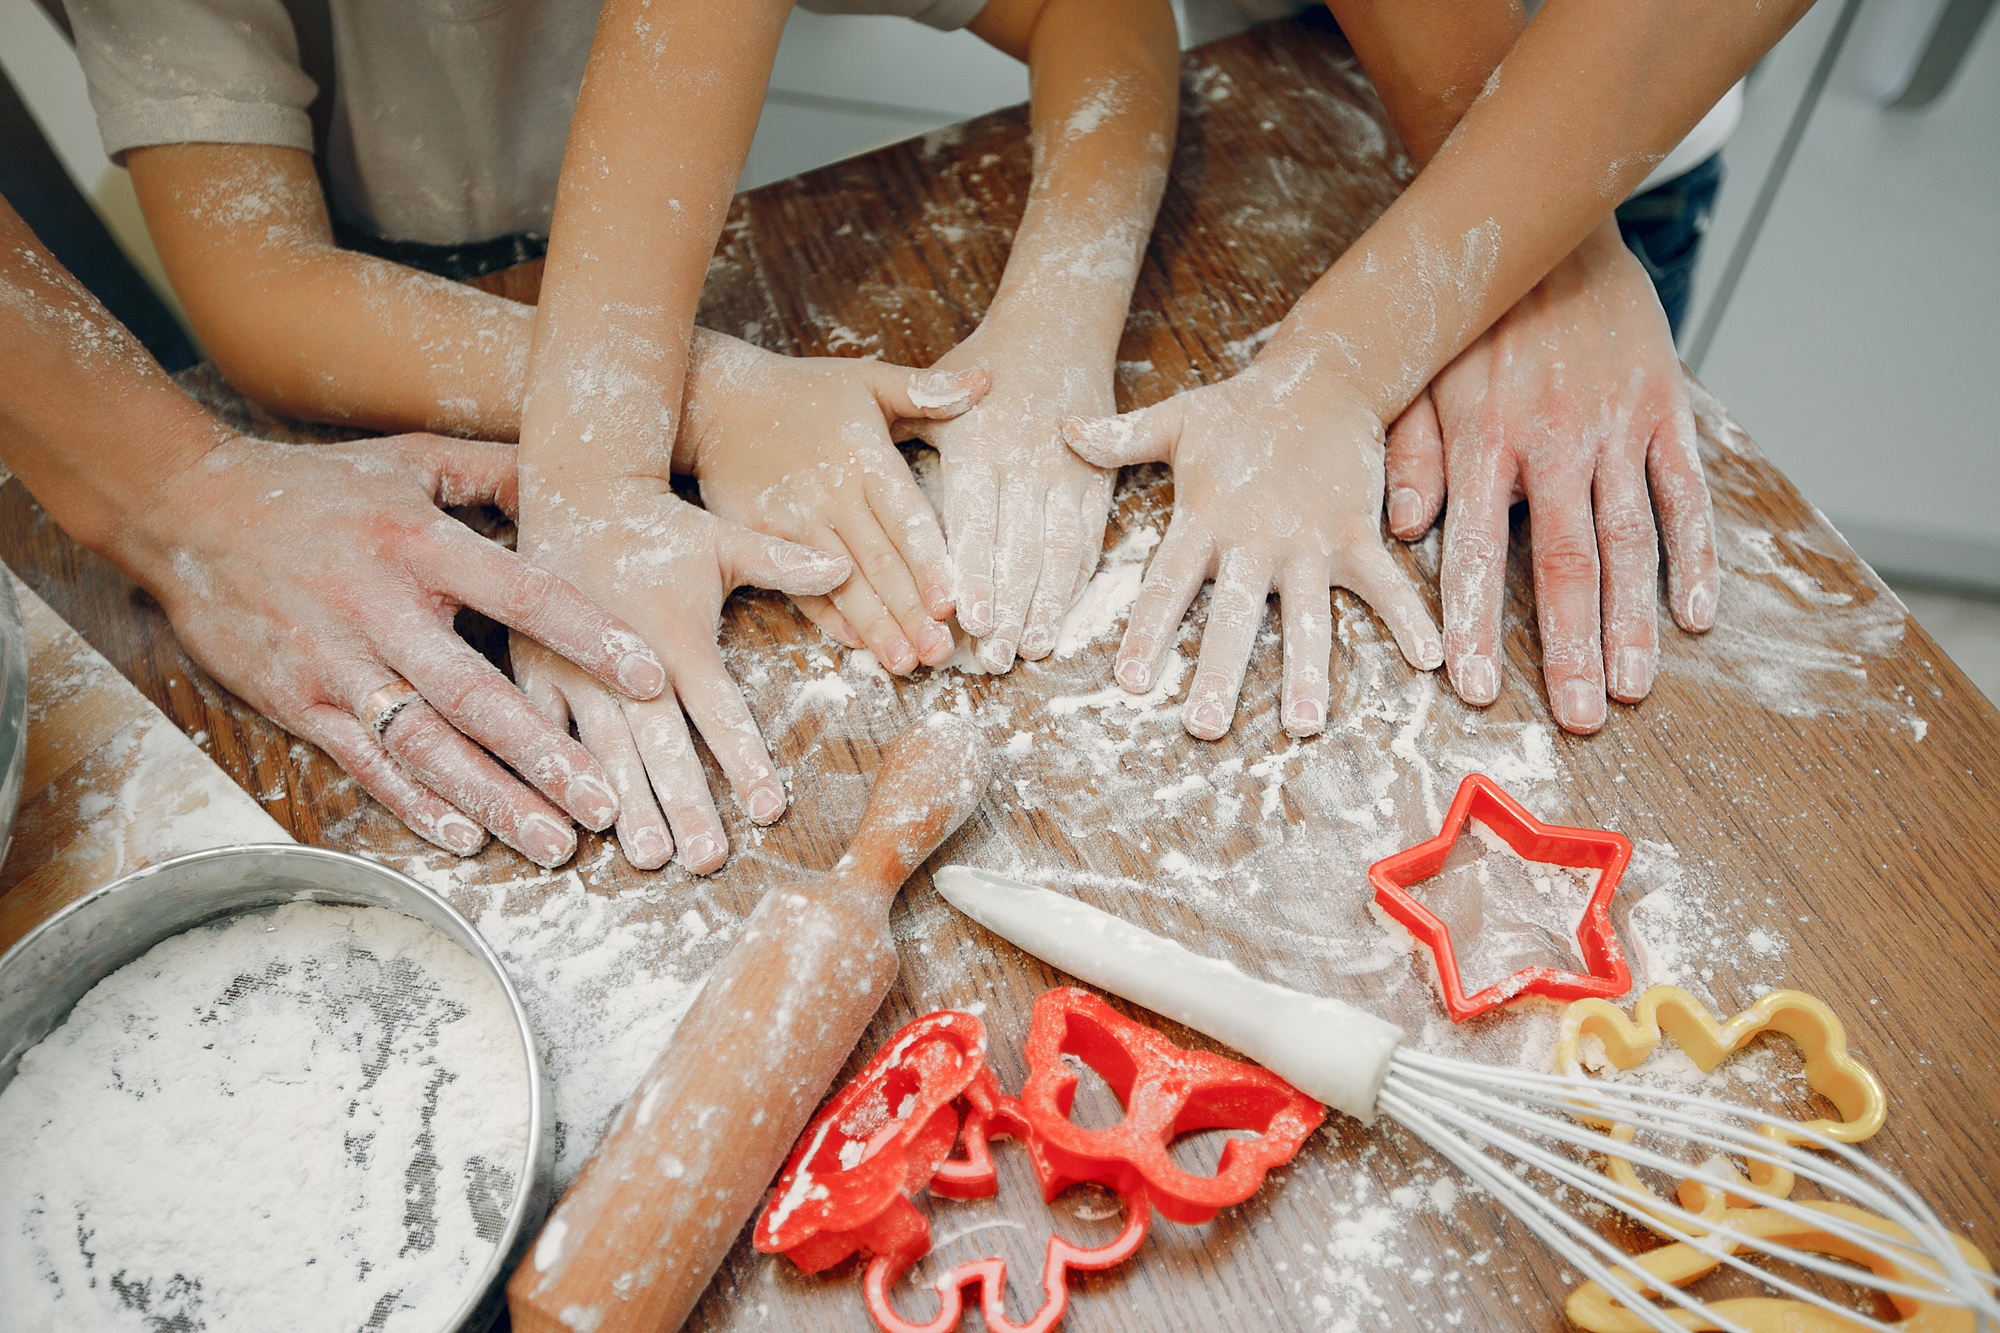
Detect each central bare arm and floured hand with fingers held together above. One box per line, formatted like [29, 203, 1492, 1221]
[922, 0, 1180, 671]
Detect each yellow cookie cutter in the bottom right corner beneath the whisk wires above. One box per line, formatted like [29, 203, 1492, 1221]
[1564, 1192, 1992, 1333]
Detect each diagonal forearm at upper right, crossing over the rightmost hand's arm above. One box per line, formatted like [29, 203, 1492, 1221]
[1260, 0, 1808, 422]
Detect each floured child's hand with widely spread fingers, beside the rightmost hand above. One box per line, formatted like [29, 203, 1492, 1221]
[1062, 358, 1444, 741]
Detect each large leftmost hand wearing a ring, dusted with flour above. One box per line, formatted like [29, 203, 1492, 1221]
[150, 434, 666, 865]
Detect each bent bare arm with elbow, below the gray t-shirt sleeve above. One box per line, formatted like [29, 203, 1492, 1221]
[126, 144, 534, 440]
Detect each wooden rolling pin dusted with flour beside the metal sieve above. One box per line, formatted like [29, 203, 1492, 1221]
[508, 713, 992, 1333]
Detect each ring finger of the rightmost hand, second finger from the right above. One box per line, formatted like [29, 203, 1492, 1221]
[1592, 440, 1660, 703]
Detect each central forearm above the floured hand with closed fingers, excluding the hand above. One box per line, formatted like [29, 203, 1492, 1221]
[974, 0, 1180, 368]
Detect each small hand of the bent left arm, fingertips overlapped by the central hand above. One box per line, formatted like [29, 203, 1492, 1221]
[676, 328, 988, 675]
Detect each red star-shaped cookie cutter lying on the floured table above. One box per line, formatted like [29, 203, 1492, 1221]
[1368, 773, 1632, 1023]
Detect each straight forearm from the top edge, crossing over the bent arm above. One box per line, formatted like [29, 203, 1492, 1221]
[520, 0, 790, 496]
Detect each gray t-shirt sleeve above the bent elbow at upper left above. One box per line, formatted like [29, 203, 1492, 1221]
[68, 0, 318, 162]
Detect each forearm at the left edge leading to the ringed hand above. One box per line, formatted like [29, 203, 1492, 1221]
[0, 204, 224, 572]
